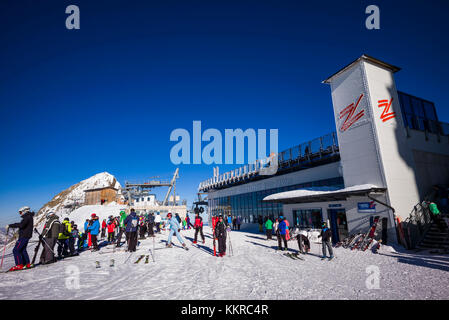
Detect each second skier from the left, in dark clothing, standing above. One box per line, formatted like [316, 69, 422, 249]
[39, 212, 61, 264]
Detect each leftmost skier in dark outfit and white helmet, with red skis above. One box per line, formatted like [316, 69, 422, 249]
[6, 206, 34, 271]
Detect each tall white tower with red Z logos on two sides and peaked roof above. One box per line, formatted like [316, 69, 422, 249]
[324, 55, 419, 231]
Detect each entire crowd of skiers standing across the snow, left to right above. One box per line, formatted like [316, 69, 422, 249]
[2, 207, 340, 271]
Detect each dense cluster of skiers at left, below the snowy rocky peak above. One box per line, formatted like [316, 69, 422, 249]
[2, 206, 175, 271]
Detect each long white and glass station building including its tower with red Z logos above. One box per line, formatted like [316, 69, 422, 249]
[199, 55, 449, 242]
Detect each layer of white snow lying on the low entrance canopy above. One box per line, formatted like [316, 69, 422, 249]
[263, 184, 379, 201]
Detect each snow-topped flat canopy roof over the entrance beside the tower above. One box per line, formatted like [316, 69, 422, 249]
[263, 184, 385, 202]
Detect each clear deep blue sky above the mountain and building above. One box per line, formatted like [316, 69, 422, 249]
[0, 0, 449, 224]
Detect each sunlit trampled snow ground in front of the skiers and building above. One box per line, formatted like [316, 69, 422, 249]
[0, 227, 449, 300]
